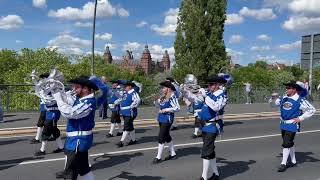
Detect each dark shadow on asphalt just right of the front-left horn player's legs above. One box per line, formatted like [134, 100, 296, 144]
[92, 152, 143, 170]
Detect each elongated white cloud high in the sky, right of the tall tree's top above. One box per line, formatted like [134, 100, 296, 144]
[239, 7, 277, 21]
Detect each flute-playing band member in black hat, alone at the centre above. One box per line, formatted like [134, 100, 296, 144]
[153, 81, 180, 164]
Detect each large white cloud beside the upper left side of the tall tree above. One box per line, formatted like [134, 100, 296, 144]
[151, 8, 179, 36]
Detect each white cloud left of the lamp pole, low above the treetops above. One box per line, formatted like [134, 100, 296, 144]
[48, 34, 91, 49]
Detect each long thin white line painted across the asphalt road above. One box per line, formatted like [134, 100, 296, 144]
[0, 129, 320, 167]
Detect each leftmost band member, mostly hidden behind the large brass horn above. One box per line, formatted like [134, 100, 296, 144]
[30, 74, 49, 144]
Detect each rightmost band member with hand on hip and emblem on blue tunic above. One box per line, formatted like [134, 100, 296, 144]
[273, 81, 316, 172]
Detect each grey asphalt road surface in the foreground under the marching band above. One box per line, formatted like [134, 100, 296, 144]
[0, 116, 320, 180]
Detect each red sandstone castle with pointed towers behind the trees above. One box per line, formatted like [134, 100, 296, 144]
[103, 45, 170, 75]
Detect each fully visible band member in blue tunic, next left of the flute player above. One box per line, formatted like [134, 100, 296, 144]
[117, 81, 141, 147]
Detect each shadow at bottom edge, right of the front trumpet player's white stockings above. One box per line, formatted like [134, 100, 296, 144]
[217, 158, 256, 179]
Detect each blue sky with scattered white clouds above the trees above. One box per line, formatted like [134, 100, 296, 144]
[0, 0, 320, 65]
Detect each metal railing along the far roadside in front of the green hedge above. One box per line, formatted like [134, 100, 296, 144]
[0, 85, 320, 112]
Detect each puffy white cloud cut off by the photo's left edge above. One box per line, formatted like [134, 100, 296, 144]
[0, 14, 24, 30]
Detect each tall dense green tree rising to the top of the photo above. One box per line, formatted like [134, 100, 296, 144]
[173, 0, 227, 82]
